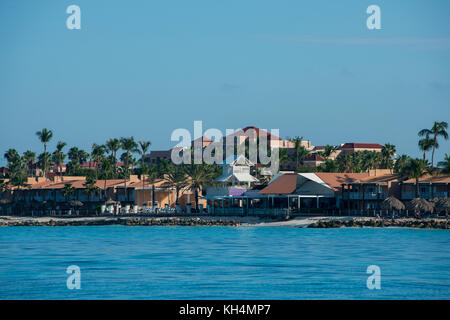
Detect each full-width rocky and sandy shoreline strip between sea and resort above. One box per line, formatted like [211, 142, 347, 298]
[0, 216, 450, 229]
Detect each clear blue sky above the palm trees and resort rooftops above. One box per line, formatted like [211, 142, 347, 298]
[0, 0, 450, 164]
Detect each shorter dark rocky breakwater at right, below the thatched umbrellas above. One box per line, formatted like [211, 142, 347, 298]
[308, 218, 450, 229]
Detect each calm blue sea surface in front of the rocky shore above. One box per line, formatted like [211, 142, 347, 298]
[0, 226, 450, 299]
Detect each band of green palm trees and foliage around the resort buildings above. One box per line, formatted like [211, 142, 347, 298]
[2, 121, 450, 203]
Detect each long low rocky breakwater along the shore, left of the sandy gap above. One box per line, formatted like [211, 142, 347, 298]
[0, 217, 240, 227]
